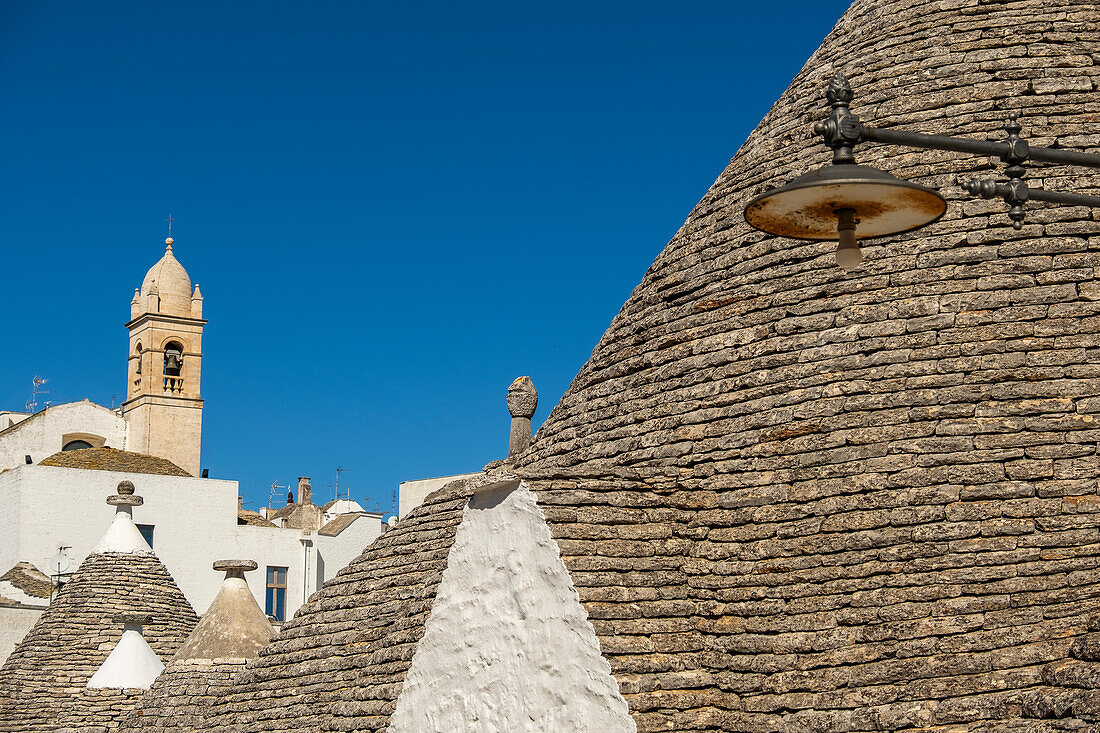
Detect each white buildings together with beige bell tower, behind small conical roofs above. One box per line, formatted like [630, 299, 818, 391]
[0, 238, 383, 661]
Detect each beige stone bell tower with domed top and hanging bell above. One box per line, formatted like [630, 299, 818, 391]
[122, 237, 206, 475]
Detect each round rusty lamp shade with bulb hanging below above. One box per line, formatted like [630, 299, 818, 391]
[745, 163, 947, 270]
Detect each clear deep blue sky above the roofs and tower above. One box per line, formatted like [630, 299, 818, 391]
[0, 0, 846, 511]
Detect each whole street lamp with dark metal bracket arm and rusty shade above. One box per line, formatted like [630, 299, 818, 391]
[745, 75, 1100, 270]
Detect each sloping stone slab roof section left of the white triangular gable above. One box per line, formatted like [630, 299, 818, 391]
[208, 477, 487, 733]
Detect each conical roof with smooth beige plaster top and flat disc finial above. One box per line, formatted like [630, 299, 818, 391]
[122, 560, 275, 733]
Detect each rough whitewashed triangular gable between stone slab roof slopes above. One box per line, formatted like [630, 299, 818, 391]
[387, 482, 636, 733]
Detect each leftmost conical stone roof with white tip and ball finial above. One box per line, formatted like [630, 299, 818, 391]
[0, 482, 198, 733]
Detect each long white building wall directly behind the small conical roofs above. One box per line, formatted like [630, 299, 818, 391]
[0, 466, 382, 619]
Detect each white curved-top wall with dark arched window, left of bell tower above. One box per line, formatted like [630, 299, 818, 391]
[0, 400, 127, 470]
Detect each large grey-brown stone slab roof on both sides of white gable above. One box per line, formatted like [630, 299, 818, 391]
[206, 0, 1100, 733]
